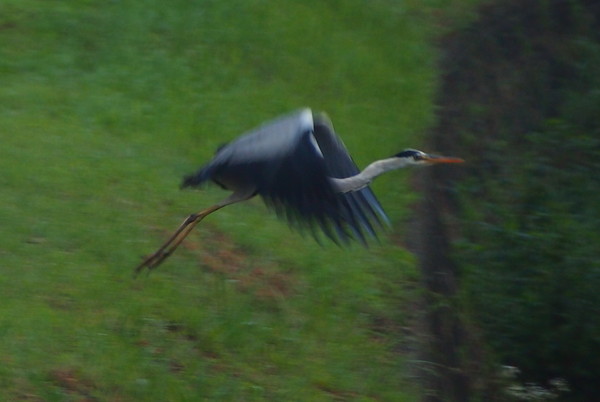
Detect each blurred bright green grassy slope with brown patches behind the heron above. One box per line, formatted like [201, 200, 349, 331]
[0, 0, 474, 401]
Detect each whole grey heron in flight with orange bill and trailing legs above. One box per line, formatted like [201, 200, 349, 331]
[135, 108, 464, 273]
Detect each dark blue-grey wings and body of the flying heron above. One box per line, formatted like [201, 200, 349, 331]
[183, 109, 387, 243]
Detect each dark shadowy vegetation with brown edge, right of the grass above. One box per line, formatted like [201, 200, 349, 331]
[429, 0, 600, 401]
